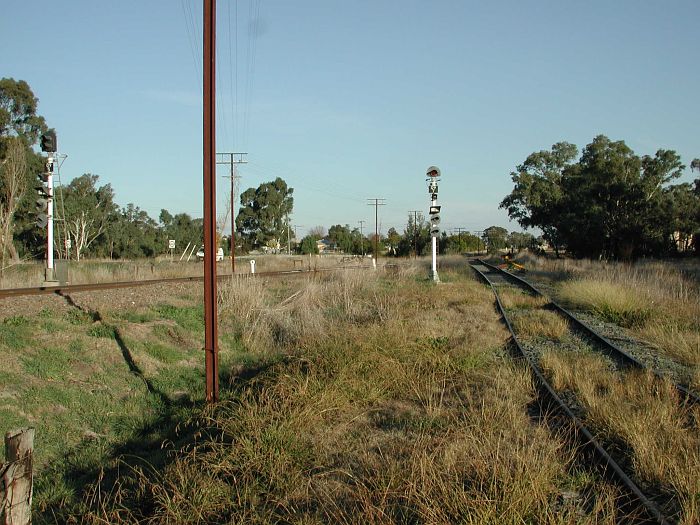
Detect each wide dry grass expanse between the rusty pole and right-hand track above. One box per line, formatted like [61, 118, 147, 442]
[61, 267, 636, 524]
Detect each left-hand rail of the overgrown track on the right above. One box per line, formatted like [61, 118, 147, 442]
[470, 260, 674, 525]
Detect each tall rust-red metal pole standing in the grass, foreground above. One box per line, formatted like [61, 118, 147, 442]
[203, 0, 219, 403]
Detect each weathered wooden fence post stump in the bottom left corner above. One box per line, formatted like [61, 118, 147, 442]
[0, 428, 34, 525]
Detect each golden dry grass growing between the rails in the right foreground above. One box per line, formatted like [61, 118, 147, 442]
[541, 353, 700, 525]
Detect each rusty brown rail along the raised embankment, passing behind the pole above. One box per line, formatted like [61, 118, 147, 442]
[0, 266, 371, 299]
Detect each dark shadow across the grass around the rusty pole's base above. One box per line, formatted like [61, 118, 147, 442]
[33, 354, 284, 524]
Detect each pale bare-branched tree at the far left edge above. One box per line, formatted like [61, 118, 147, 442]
[0, 138, 27, 275]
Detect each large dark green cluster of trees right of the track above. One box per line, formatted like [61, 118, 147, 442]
[500, 135, 700, 259]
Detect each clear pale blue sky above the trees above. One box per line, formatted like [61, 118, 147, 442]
[0, 0, 700, 236]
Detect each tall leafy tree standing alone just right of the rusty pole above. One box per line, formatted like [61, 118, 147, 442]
[236, 177, 294, 246]
